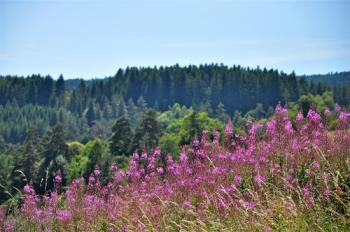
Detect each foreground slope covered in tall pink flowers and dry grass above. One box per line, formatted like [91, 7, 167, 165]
[0, 106, 350, 231]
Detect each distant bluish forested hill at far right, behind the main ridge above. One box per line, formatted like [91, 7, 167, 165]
[298, 71, 350, 86]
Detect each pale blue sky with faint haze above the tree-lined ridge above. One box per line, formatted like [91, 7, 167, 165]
[0, 0, 350, 78]
